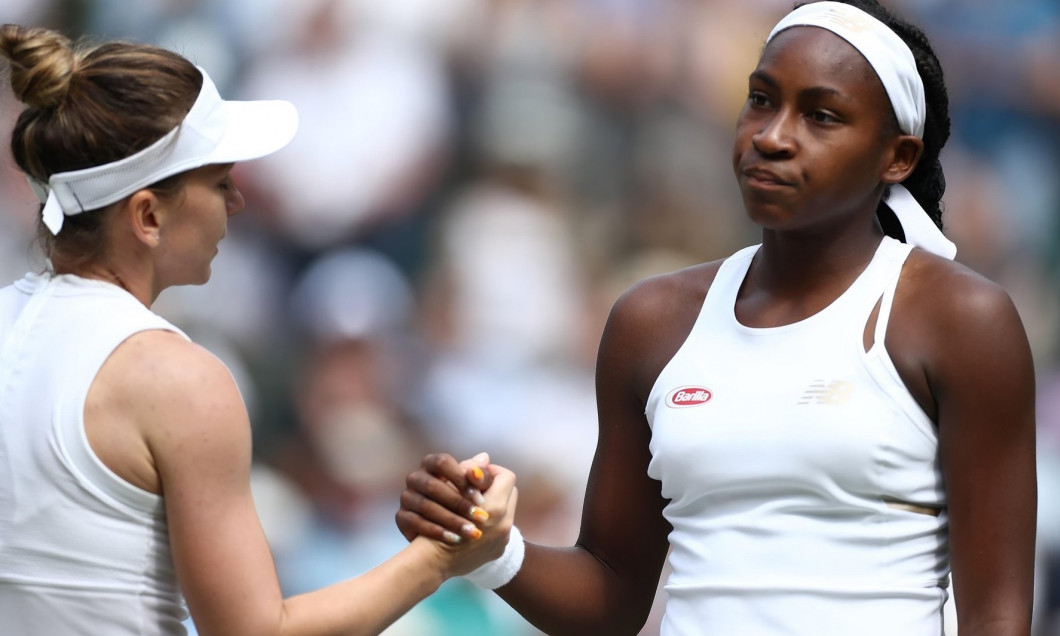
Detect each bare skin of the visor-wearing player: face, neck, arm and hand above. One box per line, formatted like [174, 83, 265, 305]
[68, 161, 517, 636]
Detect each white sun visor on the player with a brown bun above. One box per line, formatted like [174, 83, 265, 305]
[30, 68, 298, 234]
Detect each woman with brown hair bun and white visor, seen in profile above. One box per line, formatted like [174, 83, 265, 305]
[0, 25, 515, 636]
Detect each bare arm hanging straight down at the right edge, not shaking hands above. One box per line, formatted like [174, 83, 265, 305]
[888, 257, 1037, 636]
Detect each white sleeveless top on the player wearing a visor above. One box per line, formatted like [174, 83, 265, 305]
[0, 275, 187, 636]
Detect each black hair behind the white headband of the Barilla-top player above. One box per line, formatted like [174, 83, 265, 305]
[797, 0, 950, 233]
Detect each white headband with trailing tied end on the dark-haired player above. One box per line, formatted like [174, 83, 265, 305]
[765, 1, 957, 259]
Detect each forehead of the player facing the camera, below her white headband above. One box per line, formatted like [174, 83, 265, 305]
[758, 27, 886, 93]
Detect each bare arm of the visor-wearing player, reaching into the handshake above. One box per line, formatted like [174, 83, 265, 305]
[108, 332, 514, 636]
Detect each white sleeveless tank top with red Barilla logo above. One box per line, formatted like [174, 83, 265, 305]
[646, 239, 949, 636]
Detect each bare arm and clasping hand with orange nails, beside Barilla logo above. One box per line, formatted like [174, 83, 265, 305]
[398, 270, 717, 635]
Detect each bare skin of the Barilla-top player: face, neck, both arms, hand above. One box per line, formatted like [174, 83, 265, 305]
[398, 28, 1037, 636]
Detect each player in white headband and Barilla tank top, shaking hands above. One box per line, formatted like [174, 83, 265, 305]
[398, 0, 1037, 636]
